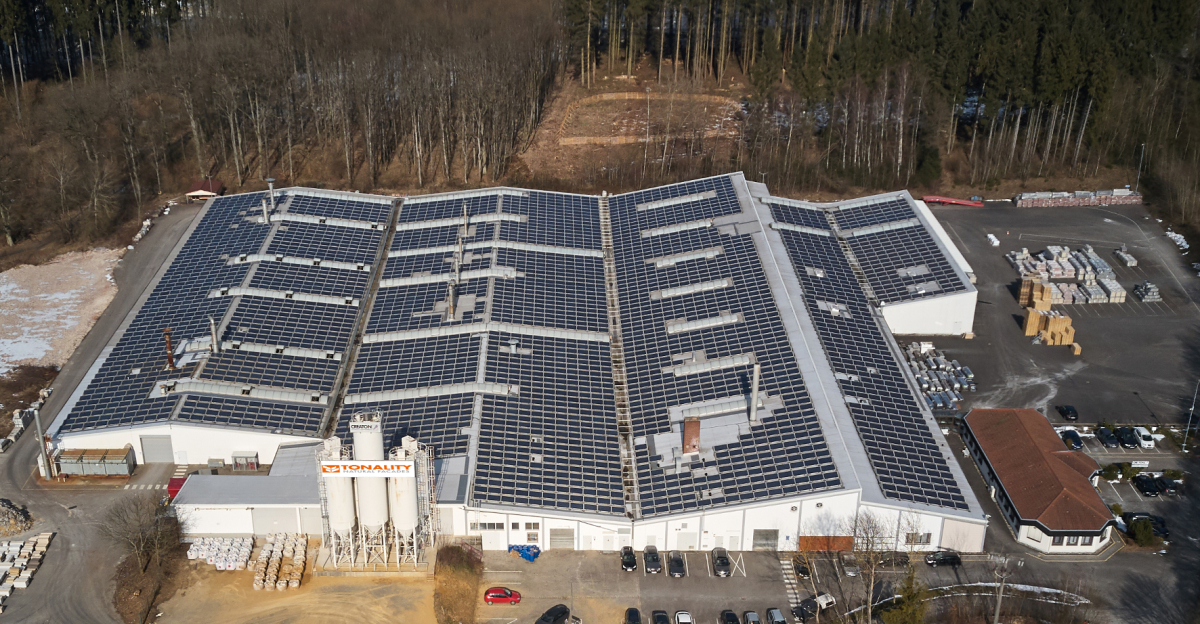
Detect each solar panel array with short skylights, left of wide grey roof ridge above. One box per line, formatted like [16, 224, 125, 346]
[610, 178, 841, 516]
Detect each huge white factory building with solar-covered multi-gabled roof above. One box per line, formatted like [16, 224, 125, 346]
[50, 174, 986, 557]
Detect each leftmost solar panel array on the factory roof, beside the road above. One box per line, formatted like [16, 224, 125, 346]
[59, 191, 391, 434]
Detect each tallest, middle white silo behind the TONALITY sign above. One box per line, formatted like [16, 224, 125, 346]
[349, 412, 388, 564]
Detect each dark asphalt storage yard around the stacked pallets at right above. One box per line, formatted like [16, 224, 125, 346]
[916, 203, 1200, 427]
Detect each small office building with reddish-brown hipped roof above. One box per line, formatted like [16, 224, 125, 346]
[962, 409, 1115, 553]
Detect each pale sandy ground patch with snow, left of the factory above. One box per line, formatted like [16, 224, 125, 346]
[0, 248, 125, 374]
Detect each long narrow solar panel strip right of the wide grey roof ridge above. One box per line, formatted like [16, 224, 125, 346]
[775, 222, 967, 509]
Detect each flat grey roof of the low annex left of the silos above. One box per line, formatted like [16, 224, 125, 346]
[174, 474, 320, 506]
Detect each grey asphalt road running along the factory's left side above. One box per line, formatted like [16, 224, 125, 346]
[0, 205, 200, 624]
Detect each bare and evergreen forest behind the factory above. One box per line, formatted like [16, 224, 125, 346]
[0, 0, 1200, 246]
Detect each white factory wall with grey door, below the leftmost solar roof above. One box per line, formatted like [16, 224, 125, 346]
[59, 424, 316, 464]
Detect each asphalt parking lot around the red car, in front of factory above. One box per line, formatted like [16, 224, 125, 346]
[476, 551, 809, 624]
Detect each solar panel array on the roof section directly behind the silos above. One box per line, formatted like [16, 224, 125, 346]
[337, 190, 624, 514]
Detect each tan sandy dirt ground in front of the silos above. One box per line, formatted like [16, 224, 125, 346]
[149, 560, 434, 624]
